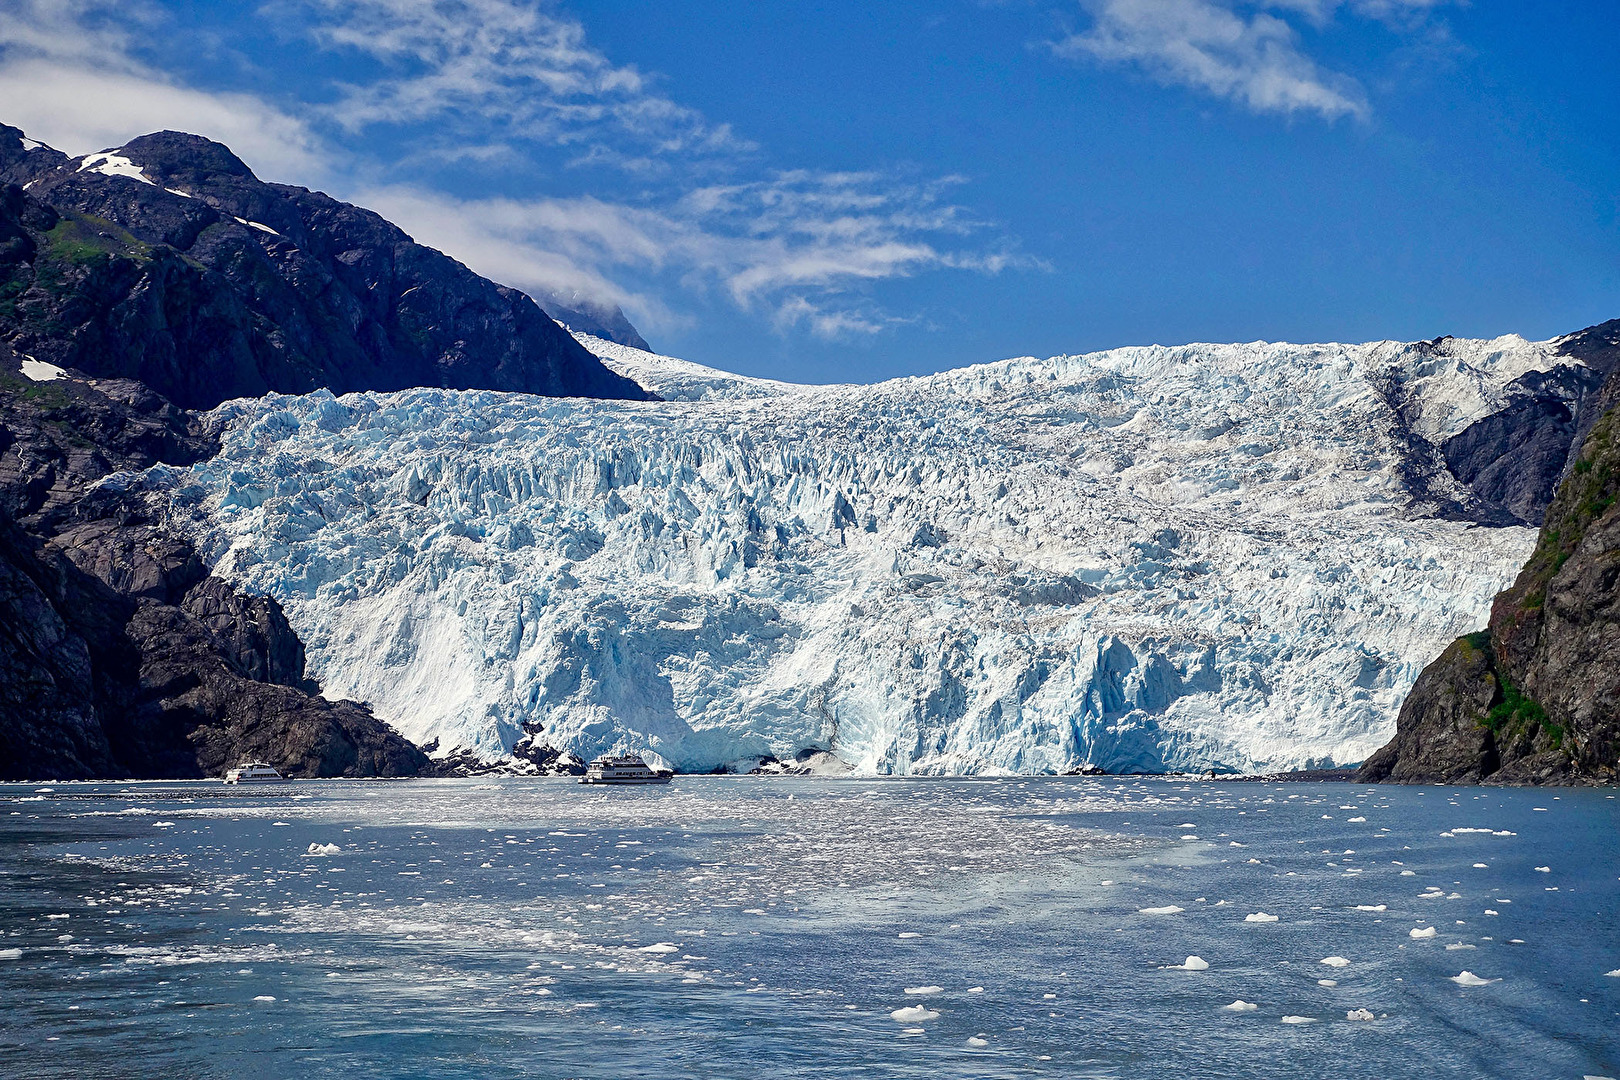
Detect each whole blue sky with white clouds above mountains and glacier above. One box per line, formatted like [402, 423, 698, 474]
[0, 0, 1620, 381]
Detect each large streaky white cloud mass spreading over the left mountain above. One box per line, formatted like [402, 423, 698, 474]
[0, 0, 1035, 337]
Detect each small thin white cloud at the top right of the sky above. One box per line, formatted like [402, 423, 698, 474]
[1053, 0, 1448, 120]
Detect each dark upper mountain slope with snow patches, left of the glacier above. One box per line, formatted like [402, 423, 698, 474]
[0, 126, 650, 408]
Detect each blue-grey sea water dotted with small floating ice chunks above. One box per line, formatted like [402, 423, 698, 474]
[0, 777, 1620, 1080]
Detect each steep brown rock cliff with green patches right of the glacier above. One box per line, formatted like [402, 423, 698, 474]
[1358, 321, 1620, 784]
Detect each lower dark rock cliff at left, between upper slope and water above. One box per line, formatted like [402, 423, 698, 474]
[0, 347, 429, 779]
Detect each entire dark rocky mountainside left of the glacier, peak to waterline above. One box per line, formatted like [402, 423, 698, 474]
[0, 126, 651, 779]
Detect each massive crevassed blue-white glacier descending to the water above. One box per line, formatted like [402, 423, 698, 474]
[146, 338, 1573, 774]
